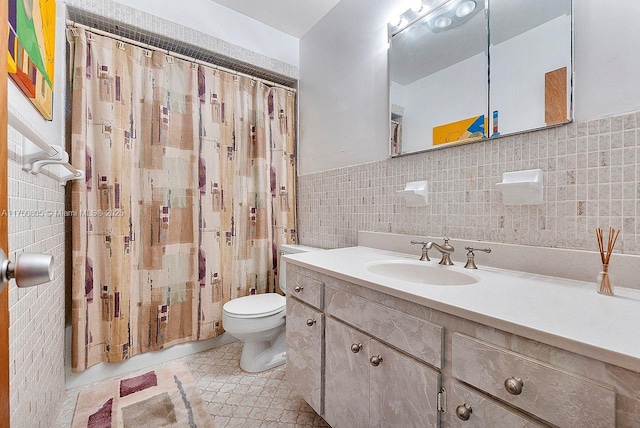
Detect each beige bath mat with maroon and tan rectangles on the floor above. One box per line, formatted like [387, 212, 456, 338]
[71, 363, 213, 428]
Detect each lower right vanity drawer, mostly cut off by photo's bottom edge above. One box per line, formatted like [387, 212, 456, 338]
[447, 382, 546, 428]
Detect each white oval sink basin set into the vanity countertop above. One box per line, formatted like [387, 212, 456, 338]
[364, 260, 478, 285]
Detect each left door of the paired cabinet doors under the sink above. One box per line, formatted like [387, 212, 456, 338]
[324, 318, 370, 428]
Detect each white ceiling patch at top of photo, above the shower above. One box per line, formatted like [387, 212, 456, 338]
[212, 0, 340, 39]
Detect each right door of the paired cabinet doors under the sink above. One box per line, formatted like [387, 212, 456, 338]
[369, 339, 440, 428]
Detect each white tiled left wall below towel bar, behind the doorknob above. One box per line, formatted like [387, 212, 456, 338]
[7, 127, 65, 428]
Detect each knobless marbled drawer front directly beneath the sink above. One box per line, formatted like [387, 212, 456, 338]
[325, 287, 443, 368]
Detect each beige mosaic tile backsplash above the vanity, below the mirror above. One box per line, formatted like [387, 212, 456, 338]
[298, 111, 640, 254]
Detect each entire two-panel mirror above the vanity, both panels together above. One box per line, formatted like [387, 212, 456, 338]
[389, 0, 572, 156]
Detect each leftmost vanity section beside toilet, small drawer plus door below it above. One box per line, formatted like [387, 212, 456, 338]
[286, 274, 324, 414]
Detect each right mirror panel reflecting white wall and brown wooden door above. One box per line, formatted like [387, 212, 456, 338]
[489, 0, 571, 135]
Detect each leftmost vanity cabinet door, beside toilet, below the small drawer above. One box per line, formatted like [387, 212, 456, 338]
[286, 298, 324, 415]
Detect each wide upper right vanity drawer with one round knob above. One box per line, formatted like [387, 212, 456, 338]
[451, 333, 615, 427]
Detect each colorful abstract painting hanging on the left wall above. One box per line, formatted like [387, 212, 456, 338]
[8, 0, 56, 120]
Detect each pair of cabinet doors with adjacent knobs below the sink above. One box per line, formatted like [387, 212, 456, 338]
[324, 317, 440, 428]
